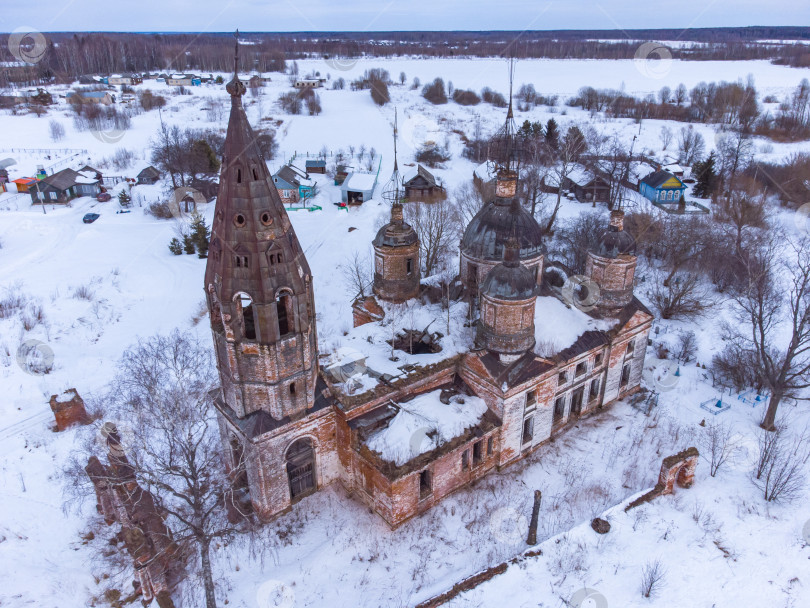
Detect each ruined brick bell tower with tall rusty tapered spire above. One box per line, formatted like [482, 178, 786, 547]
[205, 42, 318, 420]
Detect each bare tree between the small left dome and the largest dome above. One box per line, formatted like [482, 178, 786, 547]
[405, 199, 458, 277]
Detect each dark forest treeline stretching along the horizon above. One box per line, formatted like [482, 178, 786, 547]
[0, 26, 810, 86]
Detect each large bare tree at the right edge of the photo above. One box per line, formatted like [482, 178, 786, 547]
[724, 237, 810, 431]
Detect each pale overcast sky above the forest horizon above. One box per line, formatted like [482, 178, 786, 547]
[0, 0, 810, 32]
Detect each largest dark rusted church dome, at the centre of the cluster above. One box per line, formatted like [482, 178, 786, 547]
[461, 198, 545, 261]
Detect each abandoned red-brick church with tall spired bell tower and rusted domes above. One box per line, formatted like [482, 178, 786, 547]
[205, 59, 652, 527]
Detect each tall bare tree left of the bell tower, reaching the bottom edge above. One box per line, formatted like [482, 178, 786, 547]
[106, 331, 243, 608]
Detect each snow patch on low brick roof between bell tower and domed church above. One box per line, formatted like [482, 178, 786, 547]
[366, 390, 487, 466]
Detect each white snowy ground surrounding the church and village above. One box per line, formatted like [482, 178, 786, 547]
[0, 59, 810, 608]
